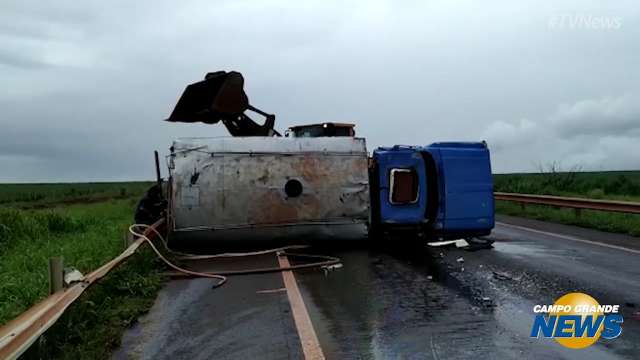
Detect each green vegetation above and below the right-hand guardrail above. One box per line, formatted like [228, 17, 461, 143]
[493, 168, 640, 236]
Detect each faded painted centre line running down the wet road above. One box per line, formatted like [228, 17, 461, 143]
[276, 255, 324, 360]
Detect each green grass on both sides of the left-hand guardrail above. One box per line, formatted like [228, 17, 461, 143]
[0, 183, 161, 358]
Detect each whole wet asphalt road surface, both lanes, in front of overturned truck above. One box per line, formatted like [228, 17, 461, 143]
[114, 217, 640, 360]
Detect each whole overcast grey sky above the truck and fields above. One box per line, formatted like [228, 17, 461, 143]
[0, 0, 640, 182]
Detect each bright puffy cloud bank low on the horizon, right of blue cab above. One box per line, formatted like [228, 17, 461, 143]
[482, 94, 640, 171]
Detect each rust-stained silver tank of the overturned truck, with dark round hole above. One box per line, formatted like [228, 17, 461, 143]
[169, 137, 369, 242]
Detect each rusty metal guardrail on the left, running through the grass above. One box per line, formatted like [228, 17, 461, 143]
[0, 220, 164, 359]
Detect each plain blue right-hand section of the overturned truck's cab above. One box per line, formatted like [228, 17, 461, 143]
[429, 143, 494, 235]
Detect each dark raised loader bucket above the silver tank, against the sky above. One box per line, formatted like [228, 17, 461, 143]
[166, 71, 249, 124]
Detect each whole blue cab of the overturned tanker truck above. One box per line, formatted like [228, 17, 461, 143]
[370, 142, 494, 240]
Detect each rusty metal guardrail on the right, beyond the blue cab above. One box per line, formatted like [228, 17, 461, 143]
[493, 192, 640, 216]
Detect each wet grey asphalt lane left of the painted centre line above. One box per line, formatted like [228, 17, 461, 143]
[113, 254, 302, 359]
